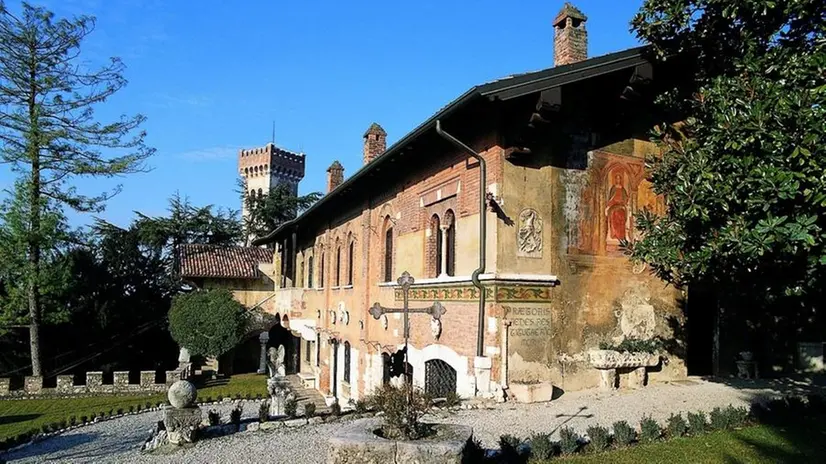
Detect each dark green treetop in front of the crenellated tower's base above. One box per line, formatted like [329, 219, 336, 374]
[239, 180, 321, 241]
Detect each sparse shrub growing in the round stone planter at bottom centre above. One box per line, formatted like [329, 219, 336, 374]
[366, 384, 433, 440]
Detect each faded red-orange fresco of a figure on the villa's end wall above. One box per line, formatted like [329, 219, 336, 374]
[568, 151, 665, 255]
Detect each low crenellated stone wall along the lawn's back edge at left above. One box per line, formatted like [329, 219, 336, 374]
[0, 364, 190, 398]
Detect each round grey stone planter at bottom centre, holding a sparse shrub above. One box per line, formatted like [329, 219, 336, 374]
[327, 419, 473, 464]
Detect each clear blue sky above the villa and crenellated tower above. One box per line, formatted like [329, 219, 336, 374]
[0, 0, 642, 225]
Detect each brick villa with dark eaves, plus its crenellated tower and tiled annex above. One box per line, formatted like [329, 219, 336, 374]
[177, 4, 686, 402]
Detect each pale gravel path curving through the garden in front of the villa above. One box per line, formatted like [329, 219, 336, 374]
[0, 380, 816, 464]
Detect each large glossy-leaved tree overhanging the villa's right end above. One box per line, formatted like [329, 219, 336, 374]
[631, 0, 826, 368]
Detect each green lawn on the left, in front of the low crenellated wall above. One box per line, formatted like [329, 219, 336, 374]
[0, 374, 267, 441]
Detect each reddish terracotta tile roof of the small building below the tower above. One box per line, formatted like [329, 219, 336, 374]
[181, 244, 273, 279]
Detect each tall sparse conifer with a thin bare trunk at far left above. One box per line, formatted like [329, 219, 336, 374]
[0, 3, 152, 375]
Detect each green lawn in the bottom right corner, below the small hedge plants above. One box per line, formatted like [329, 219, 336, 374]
[549, 421, 826, 464]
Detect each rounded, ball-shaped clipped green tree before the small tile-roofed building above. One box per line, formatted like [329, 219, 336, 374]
[169, 289, 247, 357]
